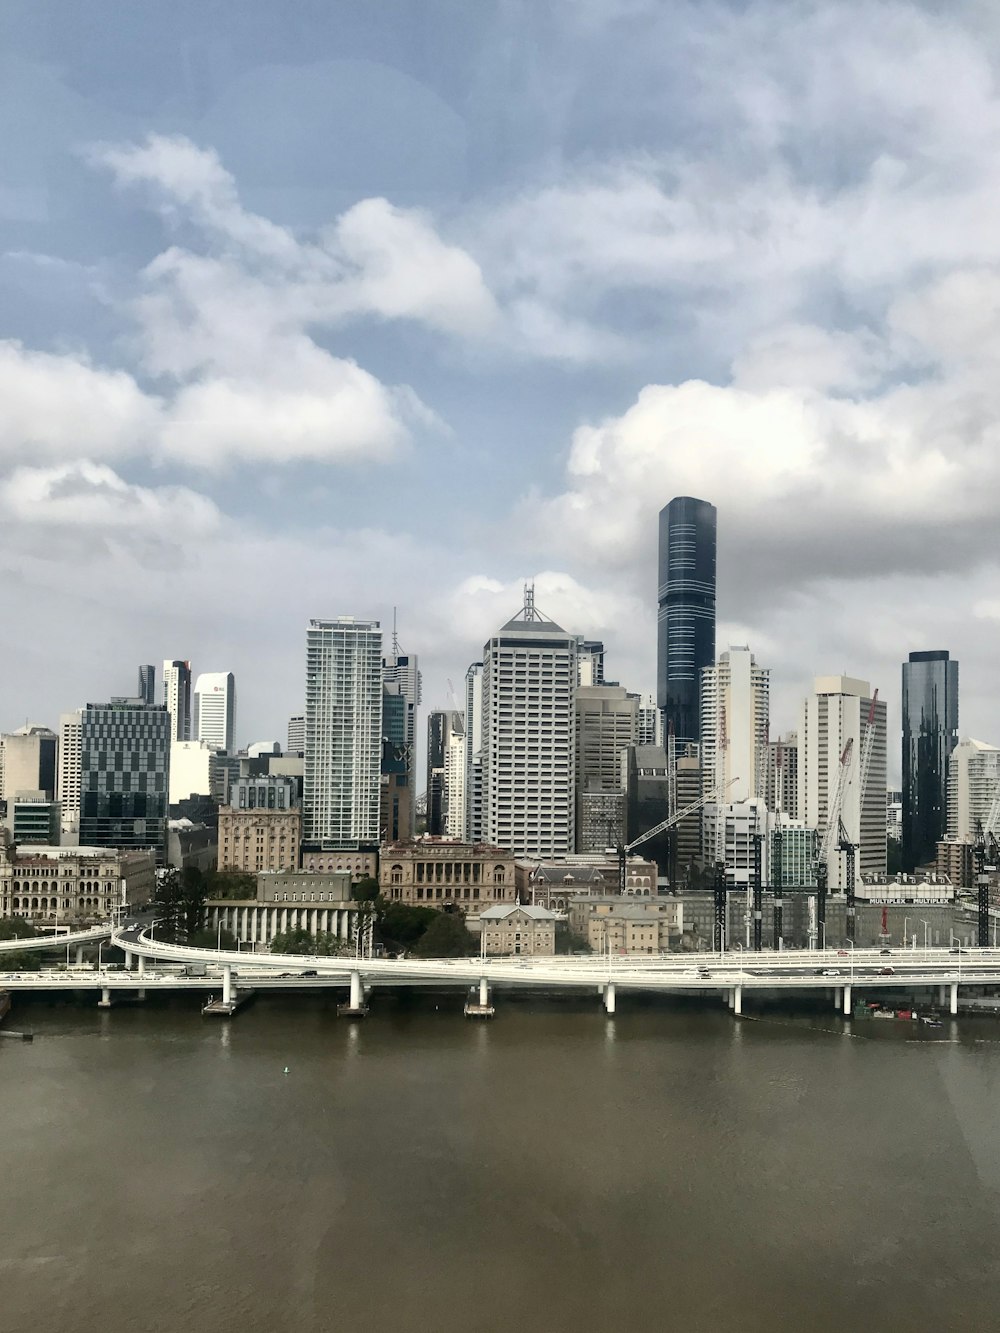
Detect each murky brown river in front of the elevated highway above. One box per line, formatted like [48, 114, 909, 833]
[0, 993, 1000, 1333]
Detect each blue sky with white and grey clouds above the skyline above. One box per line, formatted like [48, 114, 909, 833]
[0, 0, 1000, 766]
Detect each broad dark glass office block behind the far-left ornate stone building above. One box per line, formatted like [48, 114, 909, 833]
[80, 698, 173, 865]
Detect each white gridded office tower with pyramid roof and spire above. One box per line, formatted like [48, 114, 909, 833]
[483, 587, 577, 858]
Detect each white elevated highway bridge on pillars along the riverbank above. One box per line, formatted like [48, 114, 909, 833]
[0, 926, 1000, 1014]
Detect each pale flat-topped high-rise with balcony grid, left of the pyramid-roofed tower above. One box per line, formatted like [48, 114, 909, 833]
[303, 616, 383, 850]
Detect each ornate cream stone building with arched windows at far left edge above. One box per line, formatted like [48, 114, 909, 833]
[0, 845, 156, 925]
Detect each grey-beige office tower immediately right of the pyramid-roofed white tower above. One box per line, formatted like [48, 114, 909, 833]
[573, 685, 639, 852]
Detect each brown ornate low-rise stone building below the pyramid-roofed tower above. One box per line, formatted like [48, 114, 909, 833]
[379, 837, 517, 913]
